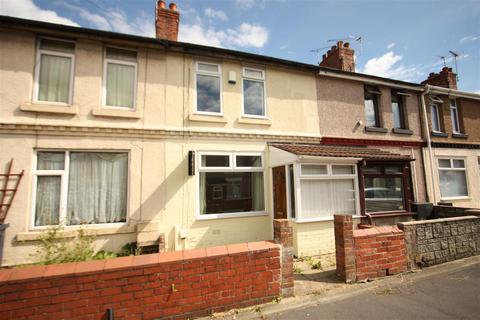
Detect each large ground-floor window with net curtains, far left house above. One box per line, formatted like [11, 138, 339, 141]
[30, 150, 128, 228]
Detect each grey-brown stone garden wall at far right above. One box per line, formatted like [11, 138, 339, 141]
[398, 216, 480, 268]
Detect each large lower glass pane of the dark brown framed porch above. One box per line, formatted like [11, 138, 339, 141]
[364, 177, 405, 212]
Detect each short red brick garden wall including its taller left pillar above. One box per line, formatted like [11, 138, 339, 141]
[334, 215, 407, 282]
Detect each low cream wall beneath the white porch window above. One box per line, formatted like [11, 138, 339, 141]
[293, 218, 360, 257]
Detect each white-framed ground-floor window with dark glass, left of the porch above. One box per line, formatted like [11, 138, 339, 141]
[198, 152, 266, 219]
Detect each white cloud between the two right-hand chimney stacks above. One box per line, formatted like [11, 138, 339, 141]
[362, 51, 421, 81]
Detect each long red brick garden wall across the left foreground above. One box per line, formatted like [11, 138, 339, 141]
[0, 241, 281, 320]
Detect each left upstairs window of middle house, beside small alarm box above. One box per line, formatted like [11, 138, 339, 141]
[195, 62, 223, 115]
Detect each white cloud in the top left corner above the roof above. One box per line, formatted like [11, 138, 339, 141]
[0, 0, 78, 26]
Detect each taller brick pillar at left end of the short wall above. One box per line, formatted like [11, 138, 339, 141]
[333, 214, 356, 283]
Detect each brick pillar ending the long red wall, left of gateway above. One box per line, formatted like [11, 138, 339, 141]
[273, 219, 293, 297]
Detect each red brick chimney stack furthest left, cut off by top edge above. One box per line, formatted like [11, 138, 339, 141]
[155, 0, 180, 41]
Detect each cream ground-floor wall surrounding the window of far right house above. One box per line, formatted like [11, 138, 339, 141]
[423, 148, 480, 208]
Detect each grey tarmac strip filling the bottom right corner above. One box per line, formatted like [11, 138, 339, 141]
[272, 263, 480, 320]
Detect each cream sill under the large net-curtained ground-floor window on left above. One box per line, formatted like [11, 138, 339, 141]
[16, 223, 135, 241]
